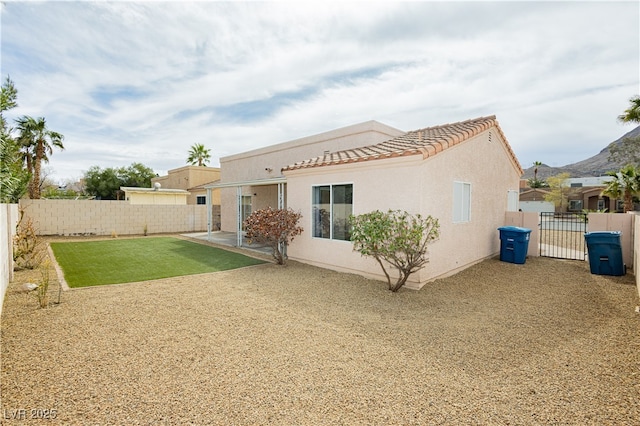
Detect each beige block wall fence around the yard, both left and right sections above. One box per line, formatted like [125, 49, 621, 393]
[0, 208, 640, 315]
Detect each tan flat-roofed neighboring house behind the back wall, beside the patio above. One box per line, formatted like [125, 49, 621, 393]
[151, 166, 220, 205]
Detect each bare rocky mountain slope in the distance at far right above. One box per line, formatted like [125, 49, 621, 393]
[522, 126, 640, 179]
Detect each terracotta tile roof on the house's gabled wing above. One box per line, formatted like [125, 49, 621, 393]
[282, 115, 523, 173]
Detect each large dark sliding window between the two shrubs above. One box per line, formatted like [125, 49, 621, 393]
[312, 184, 353, 241]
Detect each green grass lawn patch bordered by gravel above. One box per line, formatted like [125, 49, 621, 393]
[51, 237, 265, 287]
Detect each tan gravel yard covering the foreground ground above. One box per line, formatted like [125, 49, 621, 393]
[0, 240, 640, 425]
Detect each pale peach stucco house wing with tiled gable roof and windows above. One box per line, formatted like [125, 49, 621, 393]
[208, 116, 523, 288]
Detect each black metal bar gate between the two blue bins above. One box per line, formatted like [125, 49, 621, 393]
[540, 212, 588, 260]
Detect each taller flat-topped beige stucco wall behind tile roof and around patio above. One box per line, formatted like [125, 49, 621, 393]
[220, 121, 405, 231]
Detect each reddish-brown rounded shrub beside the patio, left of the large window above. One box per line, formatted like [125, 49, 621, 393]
[244, 207, 303, 265]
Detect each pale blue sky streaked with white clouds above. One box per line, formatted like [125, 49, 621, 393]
[0, 1, 640, 183]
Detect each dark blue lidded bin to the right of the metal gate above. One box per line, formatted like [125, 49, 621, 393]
[584, 231, 627, 275]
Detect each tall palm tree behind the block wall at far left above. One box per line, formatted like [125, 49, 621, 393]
[16, 115, 64, 199]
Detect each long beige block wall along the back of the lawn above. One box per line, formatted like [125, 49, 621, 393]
[20, 200, 208, 235]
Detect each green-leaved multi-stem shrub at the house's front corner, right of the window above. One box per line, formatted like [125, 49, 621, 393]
[349, 210, 440, 292]
